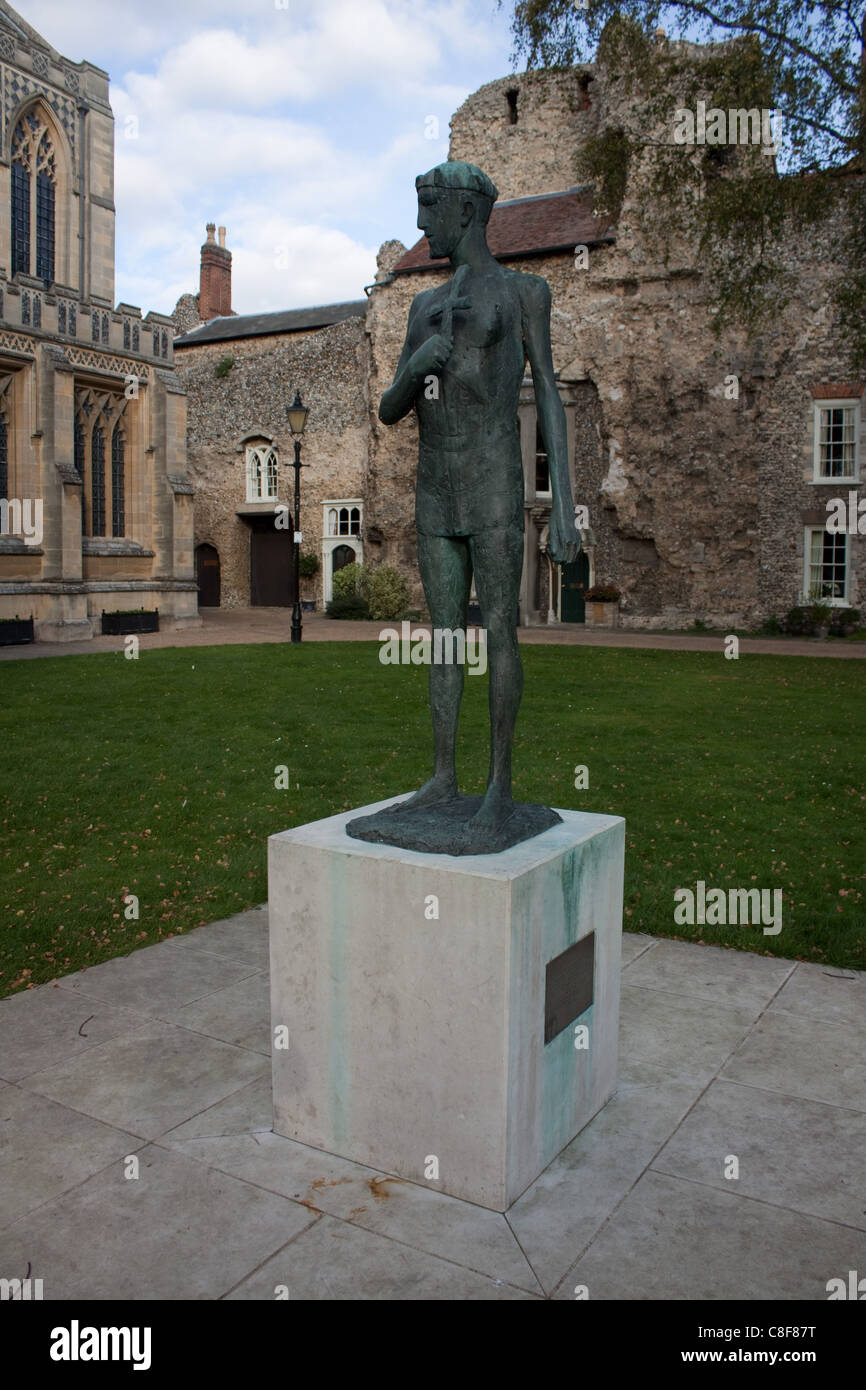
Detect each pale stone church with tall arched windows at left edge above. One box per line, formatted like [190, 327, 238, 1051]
[0, 0, 200, 641]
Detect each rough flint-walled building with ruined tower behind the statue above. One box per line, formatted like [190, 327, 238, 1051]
[175, 46, 866, 628]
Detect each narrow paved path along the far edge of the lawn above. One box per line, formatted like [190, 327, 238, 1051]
[0, 607, 866, 662]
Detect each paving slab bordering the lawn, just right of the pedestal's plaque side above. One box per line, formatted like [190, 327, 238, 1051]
[623, 941, 795, 1012]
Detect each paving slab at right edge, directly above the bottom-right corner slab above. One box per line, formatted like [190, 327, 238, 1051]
[652, 1081, 866, 1230]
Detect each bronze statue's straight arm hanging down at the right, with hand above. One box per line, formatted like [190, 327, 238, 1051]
[520, 275, 580, 564]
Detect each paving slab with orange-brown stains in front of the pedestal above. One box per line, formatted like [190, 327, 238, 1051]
[163, 1133, 541, 1293]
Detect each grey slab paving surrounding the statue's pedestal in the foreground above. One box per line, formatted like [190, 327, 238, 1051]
[0, 908, 866, 1301]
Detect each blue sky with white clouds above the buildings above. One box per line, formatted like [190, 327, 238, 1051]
[26, 0, 510, 313]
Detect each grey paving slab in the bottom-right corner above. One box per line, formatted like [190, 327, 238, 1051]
[555, 1173, 866, 1301]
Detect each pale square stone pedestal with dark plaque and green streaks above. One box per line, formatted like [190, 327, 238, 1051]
[268, 798, 626, 1211]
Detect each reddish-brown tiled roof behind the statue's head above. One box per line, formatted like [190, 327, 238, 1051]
[393, 189, 614, 275]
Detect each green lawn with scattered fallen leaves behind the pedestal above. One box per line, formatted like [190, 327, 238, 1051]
[0, 642, 866, 995]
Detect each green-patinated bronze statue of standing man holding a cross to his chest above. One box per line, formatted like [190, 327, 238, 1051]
[350, 163, 580, 853]
